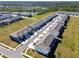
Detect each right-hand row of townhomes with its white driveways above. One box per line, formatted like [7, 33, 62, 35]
[29, 15, 68, 56]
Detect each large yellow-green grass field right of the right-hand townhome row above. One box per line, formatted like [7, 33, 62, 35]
[55, 17, 79, 58]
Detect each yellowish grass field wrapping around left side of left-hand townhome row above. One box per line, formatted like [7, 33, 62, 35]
[0, 12, 51, 48]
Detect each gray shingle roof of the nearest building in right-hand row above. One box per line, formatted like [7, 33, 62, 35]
[35, 34, 54, 51]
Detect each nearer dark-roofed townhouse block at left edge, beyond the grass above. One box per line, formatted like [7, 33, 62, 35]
[0, 16, 22, 26]
